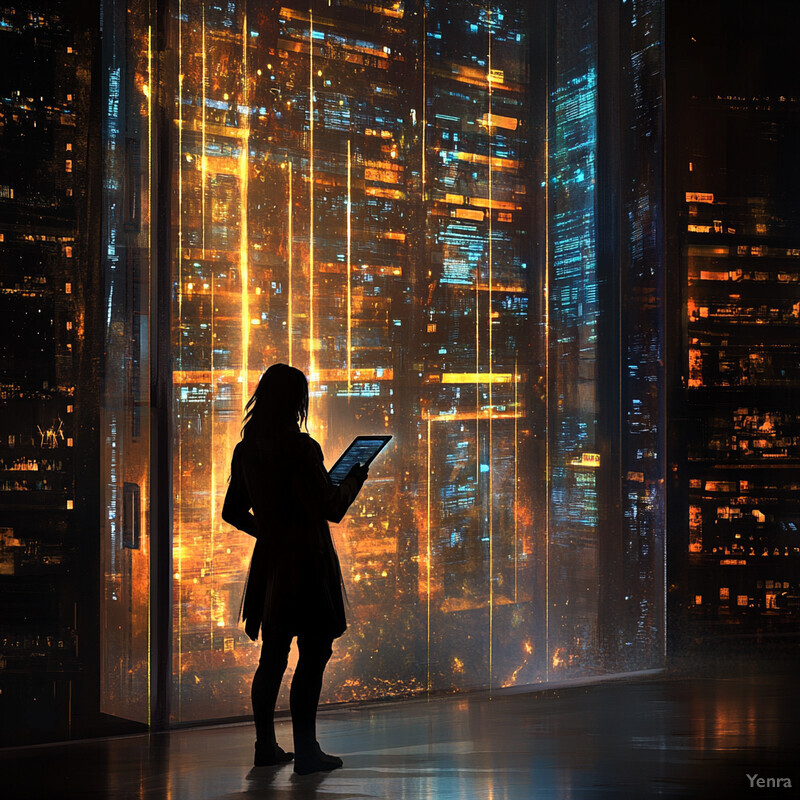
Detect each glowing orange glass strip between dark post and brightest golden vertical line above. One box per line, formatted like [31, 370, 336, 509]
[171, 2, 253, 720]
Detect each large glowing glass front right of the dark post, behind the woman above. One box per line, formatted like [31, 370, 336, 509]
[162, 0, 663, 721]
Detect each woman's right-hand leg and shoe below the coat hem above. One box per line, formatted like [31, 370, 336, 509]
[289, 634, 342, 773]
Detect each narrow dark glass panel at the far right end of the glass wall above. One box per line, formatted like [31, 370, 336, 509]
[616, 0, 666, 669]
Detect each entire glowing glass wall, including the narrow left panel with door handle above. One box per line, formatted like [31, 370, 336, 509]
[0, 0, 664, 736]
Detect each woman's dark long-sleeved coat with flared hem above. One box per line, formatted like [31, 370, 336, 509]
[222, 426, 363, 640]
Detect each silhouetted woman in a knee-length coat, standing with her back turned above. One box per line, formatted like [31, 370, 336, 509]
[222, 364, 369, 774]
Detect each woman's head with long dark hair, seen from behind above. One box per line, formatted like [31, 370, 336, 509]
[242, 364, 308, 439]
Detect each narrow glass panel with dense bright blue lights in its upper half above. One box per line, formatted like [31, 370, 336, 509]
[547, 0, 606, 674]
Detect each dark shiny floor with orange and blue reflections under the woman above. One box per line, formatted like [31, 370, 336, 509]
[0, 659, 800, 800]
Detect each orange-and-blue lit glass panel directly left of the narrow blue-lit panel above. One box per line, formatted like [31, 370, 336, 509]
[417, 3, 541, 687]
